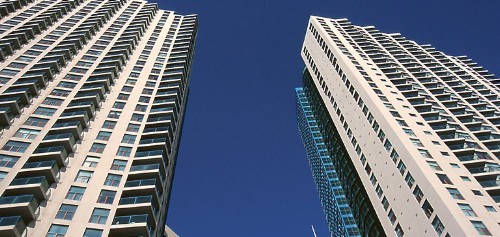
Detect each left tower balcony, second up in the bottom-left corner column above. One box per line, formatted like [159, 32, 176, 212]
[0, 194, 40, 222]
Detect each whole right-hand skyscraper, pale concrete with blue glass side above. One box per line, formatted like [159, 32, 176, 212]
[296, 17, 500, 237]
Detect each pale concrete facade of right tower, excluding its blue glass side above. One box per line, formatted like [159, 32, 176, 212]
[301, 17, 500, 237]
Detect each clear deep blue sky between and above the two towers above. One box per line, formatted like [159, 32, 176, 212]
[149, 0, 500, 237]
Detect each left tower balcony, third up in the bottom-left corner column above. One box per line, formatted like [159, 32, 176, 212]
[3, 176, 50, 202]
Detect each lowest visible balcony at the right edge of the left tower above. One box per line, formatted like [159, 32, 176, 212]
[109, 214, 155, 237]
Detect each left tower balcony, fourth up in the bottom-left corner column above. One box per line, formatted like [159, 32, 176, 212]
[18, 160, 59, 183]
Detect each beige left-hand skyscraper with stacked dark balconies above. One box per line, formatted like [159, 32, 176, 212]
[0, 0, 197, 237]
